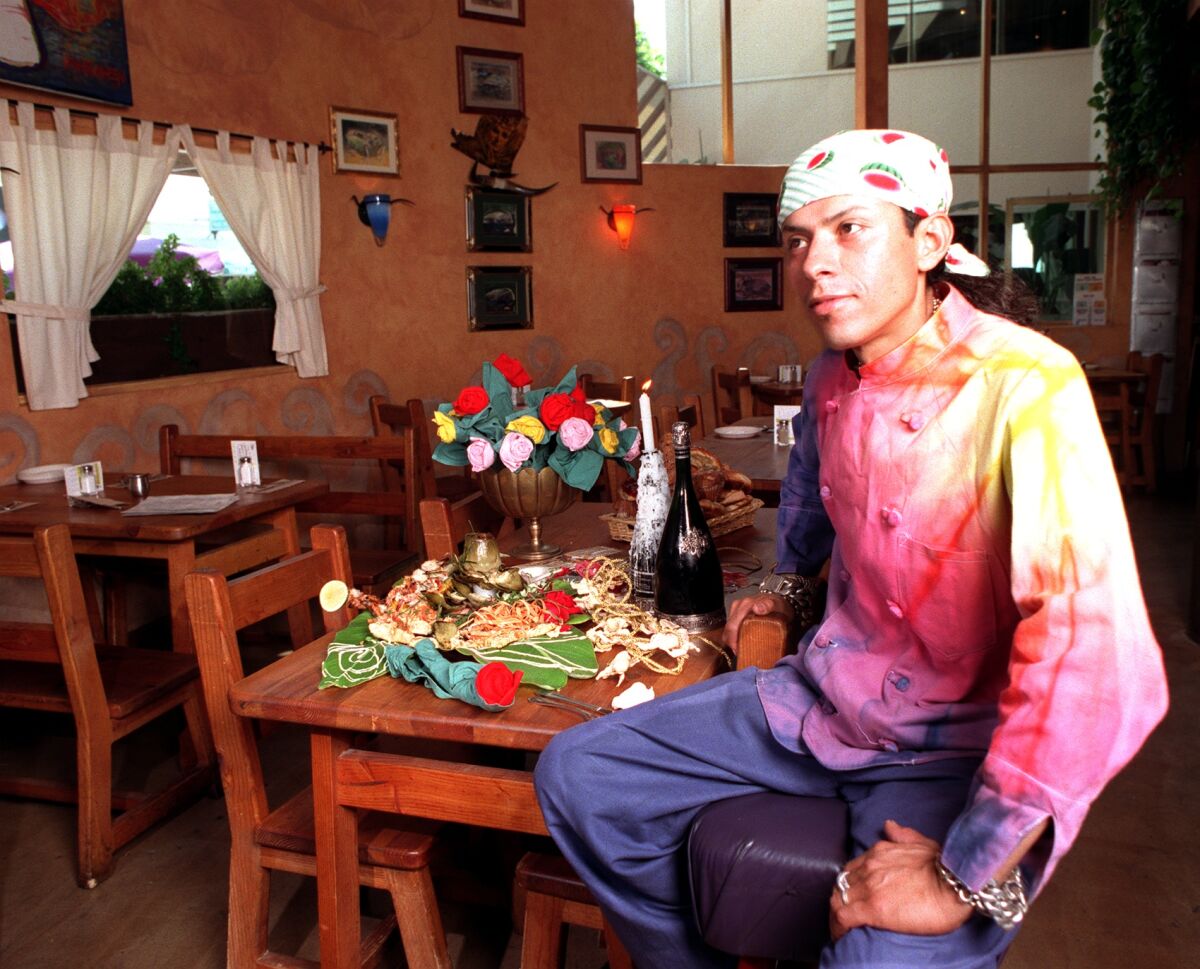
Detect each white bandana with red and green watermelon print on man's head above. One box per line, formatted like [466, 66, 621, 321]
[779, 130, 989, 276]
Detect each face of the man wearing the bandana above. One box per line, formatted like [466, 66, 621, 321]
[784, 195, 936, 363]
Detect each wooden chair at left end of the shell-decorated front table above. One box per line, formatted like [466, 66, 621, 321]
[186, 525, 450, 969]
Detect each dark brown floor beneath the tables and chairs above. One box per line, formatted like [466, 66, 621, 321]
[0, 498, 1200, 969]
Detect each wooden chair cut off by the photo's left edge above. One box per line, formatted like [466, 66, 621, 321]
[0, 524, 215, 889]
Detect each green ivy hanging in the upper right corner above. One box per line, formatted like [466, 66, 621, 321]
[1087, 0, 1195, 213]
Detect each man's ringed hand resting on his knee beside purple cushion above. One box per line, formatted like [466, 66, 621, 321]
[829, 820, 972, 941]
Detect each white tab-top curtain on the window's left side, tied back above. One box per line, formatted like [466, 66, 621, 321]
[0, 101, 180, 410]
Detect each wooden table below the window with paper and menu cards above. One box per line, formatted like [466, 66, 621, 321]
[0, 475, 329, 652]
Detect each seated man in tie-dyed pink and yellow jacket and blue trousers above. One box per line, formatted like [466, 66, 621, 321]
[536, 131, 1166, 969]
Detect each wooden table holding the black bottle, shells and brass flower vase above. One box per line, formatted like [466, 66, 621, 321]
[229, 504, 775, 969]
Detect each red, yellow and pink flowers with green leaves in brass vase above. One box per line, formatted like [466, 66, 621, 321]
[433, 354, 642, 490]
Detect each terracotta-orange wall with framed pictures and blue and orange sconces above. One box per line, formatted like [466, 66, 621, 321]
[0, 0, 818, 481]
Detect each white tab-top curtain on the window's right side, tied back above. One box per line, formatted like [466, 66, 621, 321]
[181, 126, 329, 377]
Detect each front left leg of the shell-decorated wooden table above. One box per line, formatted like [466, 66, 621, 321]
[311, 729, 360, 969]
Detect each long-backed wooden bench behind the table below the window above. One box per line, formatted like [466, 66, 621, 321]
[158, 426, 432, 594]
